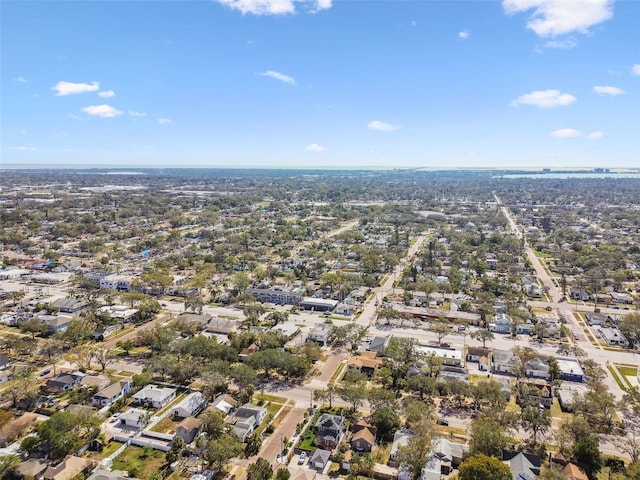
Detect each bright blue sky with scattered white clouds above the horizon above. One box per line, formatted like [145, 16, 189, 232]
[0, 0, 640, 168]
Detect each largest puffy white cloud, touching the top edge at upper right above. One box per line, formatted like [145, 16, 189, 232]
[502, 0, 613, 37]
